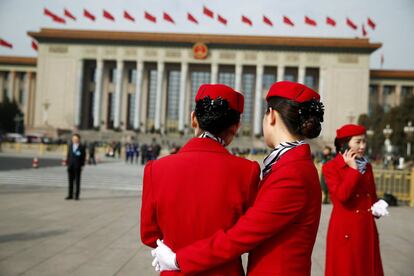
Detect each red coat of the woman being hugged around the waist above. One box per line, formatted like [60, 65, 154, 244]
[141, 138, 260, 276]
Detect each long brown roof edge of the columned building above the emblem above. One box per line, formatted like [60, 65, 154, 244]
[28, 28, 382, 53]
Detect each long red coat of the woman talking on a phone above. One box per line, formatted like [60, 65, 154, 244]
[322, 154, 384, 276]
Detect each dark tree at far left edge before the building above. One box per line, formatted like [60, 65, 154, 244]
[0, 97, 23, 133]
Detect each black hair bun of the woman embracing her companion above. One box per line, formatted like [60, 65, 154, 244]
[298, 100, 325, 139]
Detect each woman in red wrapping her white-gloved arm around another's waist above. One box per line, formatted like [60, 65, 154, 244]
[153, 82, 323, 276]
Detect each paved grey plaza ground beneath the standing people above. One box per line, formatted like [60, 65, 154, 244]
[0, 154, 414, 276]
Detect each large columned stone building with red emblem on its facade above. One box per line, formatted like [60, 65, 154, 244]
[0, 29, 414, 147]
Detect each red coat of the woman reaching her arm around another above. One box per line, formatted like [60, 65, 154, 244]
[176, 144, 322, 276]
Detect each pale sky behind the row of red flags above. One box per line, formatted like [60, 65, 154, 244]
[0, 0, 414, 70]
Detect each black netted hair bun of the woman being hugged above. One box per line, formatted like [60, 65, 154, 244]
[195, 96, 240, 135]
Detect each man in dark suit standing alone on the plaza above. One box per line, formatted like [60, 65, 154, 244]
[66, 133, 86, 200]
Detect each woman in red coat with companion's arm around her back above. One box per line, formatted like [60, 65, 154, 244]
[138, 84, 260, 276]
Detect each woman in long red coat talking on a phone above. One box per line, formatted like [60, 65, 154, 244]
[322, 125, 388, 276]
